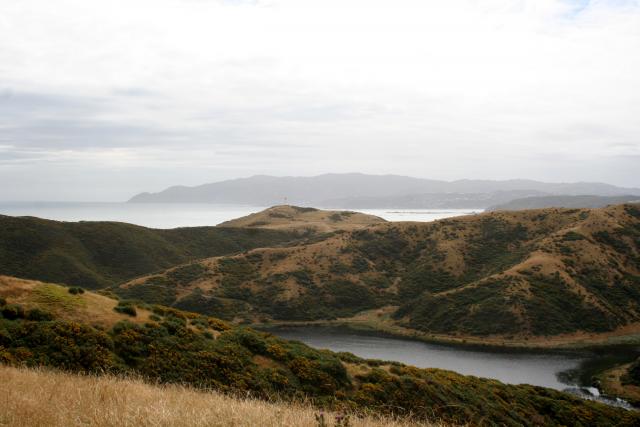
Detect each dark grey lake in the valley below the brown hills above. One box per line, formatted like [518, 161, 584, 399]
[268, 326, 640, 404]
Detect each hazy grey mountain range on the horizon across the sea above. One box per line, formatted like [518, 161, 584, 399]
[129, 173, 640, 209]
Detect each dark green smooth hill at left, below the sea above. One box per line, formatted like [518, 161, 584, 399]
[0, 215, 300, 289]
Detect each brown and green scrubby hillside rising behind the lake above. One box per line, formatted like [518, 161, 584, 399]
[115, 205, 640, 341]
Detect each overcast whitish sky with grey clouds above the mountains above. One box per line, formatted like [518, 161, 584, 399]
[0, 0, 640, 200]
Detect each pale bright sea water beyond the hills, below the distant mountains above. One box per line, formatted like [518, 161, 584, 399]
[0, 202, 482, 228]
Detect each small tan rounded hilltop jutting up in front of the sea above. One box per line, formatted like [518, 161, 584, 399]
[218, 205, 386, 233]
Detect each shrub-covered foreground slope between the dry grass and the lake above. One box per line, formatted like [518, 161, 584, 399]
[0, 276, 640, 426]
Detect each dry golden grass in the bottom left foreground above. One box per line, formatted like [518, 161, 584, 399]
[0, 366, 439, 427]
